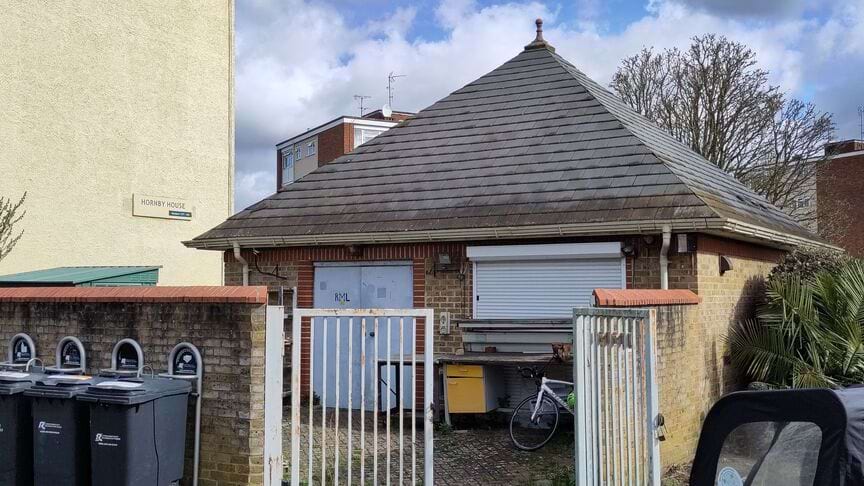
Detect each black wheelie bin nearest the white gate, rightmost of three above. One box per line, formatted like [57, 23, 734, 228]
[77, 377, 192, 486]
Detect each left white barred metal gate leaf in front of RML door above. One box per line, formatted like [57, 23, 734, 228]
[290, 309, 435, 486]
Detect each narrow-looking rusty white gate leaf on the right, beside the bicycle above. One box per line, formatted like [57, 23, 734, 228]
[573, 308, 662, 486]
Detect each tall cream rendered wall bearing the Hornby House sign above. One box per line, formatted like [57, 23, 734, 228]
[0, 0, 234, 285]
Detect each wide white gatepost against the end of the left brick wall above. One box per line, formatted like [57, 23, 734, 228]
[264, 306, 293, 486]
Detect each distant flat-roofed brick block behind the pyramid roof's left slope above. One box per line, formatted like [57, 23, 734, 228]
[276, 110, 412, 190]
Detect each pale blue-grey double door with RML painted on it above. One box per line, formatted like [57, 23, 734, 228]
[312, 262, 414, 410]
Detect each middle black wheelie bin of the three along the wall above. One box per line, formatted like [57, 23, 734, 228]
[24, 375, 104, 486]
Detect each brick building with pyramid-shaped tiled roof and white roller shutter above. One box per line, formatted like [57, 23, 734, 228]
[186, 22, 825, 464]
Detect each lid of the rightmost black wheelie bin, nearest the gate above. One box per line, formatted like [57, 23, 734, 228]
[77, 377, 192, 405]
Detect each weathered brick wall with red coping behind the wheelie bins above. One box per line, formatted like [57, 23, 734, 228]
[0, 287, 266, 486]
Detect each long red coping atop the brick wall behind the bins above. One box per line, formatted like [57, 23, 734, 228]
[0, 286, 267, 304]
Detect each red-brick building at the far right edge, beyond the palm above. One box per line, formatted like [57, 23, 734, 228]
[816, 140, 864, 257]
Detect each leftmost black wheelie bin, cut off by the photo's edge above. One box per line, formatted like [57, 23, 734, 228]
[0, 371, 45, 486]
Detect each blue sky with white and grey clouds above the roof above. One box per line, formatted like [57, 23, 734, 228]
[235, 0, 864, 210]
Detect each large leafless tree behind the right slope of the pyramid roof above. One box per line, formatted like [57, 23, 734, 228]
[611, 35, 834, 228]
